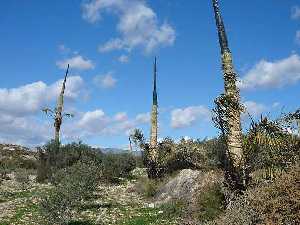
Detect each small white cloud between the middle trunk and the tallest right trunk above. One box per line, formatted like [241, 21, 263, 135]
[171, 106, 211, 128]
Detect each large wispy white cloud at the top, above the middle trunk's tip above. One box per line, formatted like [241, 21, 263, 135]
[82, 0, 176, 53]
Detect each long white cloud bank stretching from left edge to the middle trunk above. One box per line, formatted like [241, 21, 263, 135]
[0, 73, 149, 146]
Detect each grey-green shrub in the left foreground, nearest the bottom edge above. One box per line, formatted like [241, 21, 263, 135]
[40, 162, 99, 224]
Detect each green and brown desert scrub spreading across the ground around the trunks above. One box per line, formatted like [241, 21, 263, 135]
[0, 106, 300, 225]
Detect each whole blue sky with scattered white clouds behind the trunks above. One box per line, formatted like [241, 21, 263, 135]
[0, 0, 300, 148]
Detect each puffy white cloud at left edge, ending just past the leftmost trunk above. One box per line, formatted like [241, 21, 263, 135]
[0, 76, 84, 145]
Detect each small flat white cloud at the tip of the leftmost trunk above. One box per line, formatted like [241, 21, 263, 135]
[56, 55, 95, 70]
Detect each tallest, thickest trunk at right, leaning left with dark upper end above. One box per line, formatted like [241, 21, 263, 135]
[212, 0, 245, 186]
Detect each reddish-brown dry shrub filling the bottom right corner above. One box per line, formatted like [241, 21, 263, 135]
[210, 166, 300, 225]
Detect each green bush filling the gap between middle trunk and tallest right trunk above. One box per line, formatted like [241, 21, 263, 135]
[144, 138, 224, 177]
